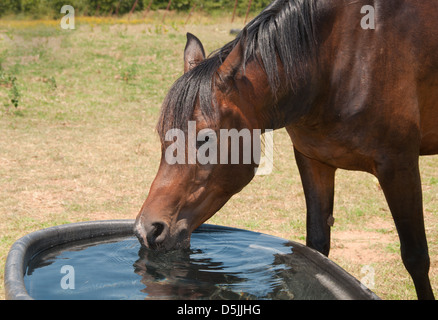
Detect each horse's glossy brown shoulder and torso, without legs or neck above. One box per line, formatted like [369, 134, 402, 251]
[287, 1, 438, 169]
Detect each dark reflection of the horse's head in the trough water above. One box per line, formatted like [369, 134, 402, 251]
[134, 248, 293, 300]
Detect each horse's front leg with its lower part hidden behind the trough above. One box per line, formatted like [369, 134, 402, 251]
[294, 149, 336, 256]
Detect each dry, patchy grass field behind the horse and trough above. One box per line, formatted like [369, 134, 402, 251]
[0, 16, 438, 299]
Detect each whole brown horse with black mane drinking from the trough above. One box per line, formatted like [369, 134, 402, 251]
[135, 0, 438, 299]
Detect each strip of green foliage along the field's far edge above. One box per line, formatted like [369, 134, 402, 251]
[0, 0, 271, 18]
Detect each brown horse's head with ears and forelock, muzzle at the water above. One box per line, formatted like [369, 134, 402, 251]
[134, 34, 266, 250]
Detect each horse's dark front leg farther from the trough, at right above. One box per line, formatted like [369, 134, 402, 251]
[377, 156, 434, 299]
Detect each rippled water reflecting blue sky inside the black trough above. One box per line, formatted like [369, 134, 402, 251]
[24, 226, 342, 300]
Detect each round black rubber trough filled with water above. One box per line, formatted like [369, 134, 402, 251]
[4, 220, 379, 300]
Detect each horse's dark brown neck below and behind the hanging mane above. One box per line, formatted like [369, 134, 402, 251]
[245, 0, 338, 130]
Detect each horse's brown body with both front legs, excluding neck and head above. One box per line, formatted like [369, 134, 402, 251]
[287, 1, 438, 298]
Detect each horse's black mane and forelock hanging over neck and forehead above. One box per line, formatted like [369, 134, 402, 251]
[157, 0, 316, 141]
